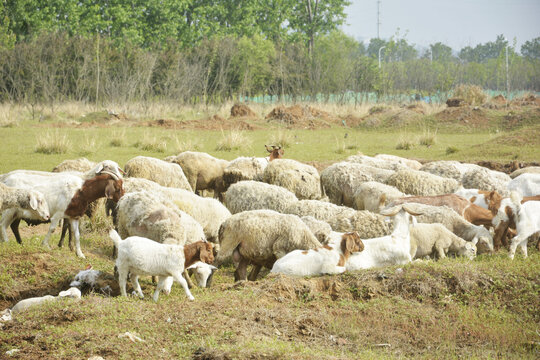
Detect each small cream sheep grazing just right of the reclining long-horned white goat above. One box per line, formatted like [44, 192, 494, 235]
[410, 224, 478, 260]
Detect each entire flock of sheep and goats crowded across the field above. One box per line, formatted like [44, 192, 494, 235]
[0, 146, 540, 301]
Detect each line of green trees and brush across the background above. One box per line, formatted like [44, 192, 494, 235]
[0, 0, 540, 106]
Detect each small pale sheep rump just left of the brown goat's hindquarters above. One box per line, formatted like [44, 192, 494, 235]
[352, 181, 405, 213]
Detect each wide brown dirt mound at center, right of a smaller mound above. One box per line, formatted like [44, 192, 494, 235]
[265, 105, 330, 128]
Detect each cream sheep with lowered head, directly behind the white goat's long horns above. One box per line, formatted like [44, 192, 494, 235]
[388, 203, 493, 254]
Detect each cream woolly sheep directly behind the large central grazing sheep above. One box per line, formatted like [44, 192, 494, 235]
[223, 181, 298, 214]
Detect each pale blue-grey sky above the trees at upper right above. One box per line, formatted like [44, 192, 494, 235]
[342, 0, 540, 51]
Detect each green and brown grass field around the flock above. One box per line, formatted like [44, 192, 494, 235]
[0, 102, 540, 359]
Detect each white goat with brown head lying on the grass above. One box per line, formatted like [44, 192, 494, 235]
[271, 232, 364, 276]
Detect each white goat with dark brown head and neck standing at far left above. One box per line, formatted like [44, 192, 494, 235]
[0, 172, 123, 258]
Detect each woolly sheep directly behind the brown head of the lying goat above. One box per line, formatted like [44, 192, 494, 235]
[284, 200, 390, 239]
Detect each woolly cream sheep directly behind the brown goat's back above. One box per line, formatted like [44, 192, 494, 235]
[386, 170, 459, 196]
